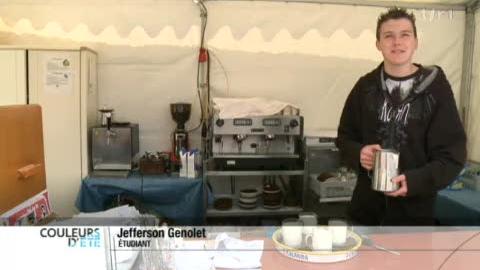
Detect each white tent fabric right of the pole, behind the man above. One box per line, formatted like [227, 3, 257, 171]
[204, 2, 465, 137]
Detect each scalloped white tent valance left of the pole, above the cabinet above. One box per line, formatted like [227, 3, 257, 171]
[0, 0, 199, 38]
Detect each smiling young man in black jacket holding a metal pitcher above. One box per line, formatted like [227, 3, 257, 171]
[337, 8, 466, 225]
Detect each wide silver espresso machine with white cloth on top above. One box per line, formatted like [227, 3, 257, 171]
[210, 114, 303, 170]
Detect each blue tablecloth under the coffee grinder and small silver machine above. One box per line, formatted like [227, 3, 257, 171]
[76, 174, 205, 225]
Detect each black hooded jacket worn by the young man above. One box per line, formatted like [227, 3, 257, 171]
[337, 64, 466, 225]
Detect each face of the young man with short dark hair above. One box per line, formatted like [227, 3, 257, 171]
[376, 18, 418, 66]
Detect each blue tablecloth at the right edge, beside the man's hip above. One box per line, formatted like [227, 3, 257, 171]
[435, 189, 480, 226]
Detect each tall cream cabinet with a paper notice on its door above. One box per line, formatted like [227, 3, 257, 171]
[0, 46, 97, 216]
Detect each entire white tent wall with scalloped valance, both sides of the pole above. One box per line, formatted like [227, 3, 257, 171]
[0, 0, 465, 151]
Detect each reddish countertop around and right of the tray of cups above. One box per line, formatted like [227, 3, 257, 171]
[262, 230, 480, 270]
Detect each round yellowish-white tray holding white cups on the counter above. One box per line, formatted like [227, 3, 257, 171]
[272, 229, 362, 263]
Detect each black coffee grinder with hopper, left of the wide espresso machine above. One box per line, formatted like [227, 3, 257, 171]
[170, 103, 192, 170]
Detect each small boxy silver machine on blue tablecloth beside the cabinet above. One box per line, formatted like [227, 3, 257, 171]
[92, 108, 139, 177]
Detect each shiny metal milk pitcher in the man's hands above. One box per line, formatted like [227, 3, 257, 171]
[372, 149, 400, 192]
